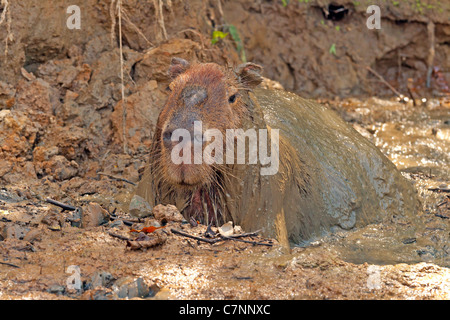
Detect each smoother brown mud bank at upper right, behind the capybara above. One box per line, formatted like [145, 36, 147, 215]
[223, 0, 450, 98]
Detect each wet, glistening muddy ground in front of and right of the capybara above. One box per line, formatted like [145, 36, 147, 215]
[0, 99, 450, 299]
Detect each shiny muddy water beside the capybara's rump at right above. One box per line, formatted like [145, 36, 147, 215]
[317, 98, 450, 267]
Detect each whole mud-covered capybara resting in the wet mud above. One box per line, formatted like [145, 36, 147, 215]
[136, 58, 418, 244]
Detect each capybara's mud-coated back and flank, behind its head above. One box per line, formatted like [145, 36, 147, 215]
[232, 89, 419, 243]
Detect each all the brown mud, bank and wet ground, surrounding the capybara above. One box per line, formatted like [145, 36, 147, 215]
[0, 0, 450, 299]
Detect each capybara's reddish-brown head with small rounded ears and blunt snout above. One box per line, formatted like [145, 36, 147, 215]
[154, 58, 262, 188]
